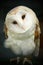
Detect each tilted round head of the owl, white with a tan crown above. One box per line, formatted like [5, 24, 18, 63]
[4, 6, 37, 38]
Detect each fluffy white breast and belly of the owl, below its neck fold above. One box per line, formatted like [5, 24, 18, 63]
[5, 29, 35, 55]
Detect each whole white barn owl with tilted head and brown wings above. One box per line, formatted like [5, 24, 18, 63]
[4, 6, 40, 64]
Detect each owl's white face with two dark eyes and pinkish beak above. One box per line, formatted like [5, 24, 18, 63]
[8, 10, 32, 33]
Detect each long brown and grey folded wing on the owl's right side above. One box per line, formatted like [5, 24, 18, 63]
[34, 20, 41, 56]
